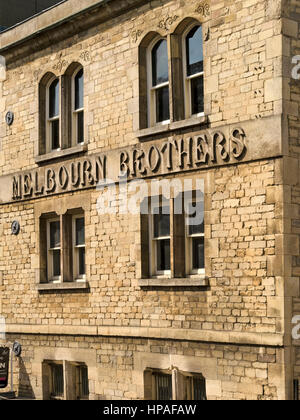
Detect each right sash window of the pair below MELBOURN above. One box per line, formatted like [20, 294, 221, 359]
[73, 215, 85, 280]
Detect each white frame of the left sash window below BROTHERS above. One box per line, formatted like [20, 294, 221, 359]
[149, 203, 171, 278]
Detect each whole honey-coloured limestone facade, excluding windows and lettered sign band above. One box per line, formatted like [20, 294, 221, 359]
[0, 0, 294, 399]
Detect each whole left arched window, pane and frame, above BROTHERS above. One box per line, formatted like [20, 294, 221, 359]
[148, 39, 170, 126]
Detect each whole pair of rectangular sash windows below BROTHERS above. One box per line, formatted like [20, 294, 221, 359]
[141, 190, 206, 285]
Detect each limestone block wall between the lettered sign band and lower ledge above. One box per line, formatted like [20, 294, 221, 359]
[0, 160, 284, 334]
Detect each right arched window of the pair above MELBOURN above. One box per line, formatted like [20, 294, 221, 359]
[72, 68, 84, 146]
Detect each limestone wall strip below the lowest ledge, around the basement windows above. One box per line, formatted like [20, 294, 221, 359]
[5, 335, 283, 400]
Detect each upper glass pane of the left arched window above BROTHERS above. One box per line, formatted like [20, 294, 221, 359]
[152, 39, 169, 86]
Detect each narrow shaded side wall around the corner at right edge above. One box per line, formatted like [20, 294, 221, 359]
[284, 0, 300, 396]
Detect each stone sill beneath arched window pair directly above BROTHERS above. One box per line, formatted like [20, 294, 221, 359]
[136, 115, 207, 140]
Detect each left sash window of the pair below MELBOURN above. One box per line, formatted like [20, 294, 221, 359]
[47, 219, 61, 282]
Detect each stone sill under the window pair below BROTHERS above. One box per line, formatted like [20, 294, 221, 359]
[139, 276, 208, 287]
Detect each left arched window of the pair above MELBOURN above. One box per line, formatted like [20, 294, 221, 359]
[46, 78, 61, 152]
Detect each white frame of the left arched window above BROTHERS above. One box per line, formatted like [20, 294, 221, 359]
[147, 37, 171, 127]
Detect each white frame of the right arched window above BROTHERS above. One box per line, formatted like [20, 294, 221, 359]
[182, 24, 205, 118]
